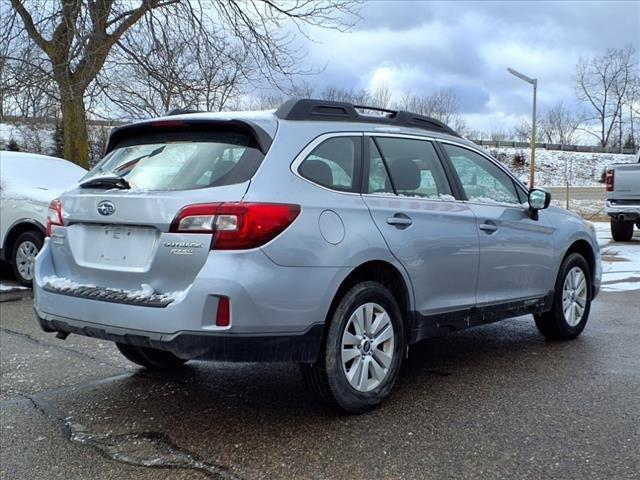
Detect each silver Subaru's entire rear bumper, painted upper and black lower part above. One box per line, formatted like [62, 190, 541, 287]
[33, 242, 349, 361]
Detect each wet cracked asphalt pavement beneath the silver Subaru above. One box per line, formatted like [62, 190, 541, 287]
[0, 290, 640, 479]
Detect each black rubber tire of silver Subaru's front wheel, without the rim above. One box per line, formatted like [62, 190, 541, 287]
[534, 253, 593, 340]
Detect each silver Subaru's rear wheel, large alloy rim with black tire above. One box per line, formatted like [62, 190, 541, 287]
[301, 282, 405, 413]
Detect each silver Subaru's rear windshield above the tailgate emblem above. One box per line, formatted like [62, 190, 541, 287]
[86, 131, 264, 190]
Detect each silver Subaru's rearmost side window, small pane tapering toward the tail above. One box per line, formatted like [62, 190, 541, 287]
[298, 137, 361, 192]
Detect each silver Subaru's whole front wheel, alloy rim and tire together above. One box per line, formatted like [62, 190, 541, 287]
[535, 253, 592, 340]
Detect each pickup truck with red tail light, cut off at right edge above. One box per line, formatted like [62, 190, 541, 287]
[605, 152, 640, 241]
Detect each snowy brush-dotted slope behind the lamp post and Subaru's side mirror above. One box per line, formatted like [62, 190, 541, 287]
[488, 147, 636, 187]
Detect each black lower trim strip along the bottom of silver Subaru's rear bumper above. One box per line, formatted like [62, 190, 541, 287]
[36, 310, 324, 362]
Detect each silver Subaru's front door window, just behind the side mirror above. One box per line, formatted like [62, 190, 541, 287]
[442, 144, 520, 204]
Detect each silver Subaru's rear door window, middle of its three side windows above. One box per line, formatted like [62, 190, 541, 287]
[369, 137, 451, 198]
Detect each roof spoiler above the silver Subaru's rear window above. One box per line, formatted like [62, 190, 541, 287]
[104, 118, 273, 155]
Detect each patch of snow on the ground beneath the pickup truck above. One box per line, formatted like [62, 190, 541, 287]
[593, 222, 640, 292]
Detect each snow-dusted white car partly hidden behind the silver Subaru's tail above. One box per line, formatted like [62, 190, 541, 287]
[0, 151, 87, 286]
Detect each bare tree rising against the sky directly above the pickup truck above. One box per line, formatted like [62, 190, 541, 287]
[576, 45, 637, 147]
